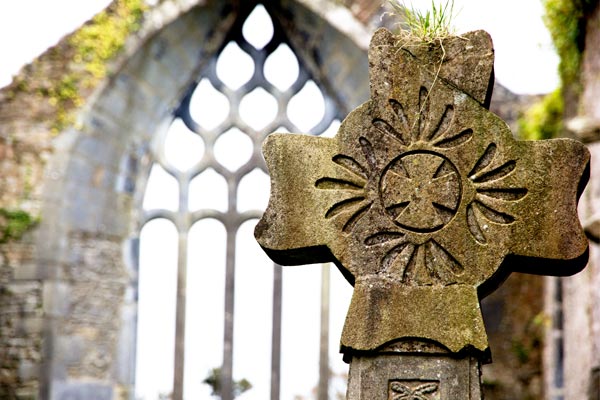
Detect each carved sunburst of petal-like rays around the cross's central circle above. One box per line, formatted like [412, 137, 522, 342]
[315, 88, 527, 285]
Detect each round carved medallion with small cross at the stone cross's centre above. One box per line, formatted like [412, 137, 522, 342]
[379, 150, 462, 233]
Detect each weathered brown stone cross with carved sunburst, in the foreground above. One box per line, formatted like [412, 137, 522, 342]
[255, 29, 589, 400]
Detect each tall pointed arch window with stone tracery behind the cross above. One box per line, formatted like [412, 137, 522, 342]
[136, 1, 360, 400]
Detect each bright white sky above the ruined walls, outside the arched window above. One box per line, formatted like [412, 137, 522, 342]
[0, 0, 558, 93]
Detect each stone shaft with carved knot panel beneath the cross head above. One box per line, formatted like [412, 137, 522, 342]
[346, 353, 482, 400]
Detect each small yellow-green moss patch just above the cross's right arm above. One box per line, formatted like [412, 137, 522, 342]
[518, 89, 564, 140]
